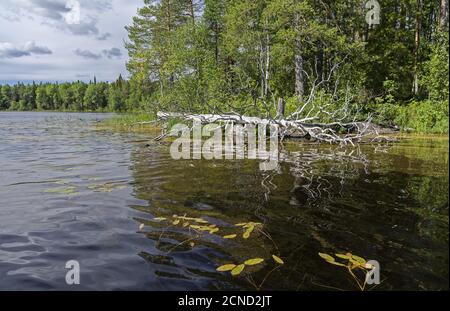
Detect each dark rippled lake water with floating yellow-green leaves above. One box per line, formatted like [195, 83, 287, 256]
[0, 113, 449, 290]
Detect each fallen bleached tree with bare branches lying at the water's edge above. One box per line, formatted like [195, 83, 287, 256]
[157, 111, 392, 145]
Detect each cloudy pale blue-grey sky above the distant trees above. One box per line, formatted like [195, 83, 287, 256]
[0, 0, 143, 84]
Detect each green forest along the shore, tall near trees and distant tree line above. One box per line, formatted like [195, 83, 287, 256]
[0, 0, 449, 132]
